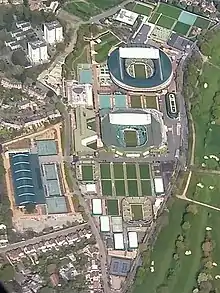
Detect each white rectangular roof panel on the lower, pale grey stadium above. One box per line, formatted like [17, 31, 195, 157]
[109, 113, 151, 125]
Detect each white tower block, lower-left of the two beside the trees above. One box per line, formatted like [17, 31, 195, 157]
[28, 40, 49, 64]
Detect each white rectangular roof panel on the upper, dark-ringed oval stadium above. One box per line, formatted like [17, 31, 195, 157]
[119, 47, 160, 59]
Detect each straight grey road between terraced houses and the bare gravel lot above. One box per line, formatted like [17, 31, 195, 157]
[0, 223, 88, 253]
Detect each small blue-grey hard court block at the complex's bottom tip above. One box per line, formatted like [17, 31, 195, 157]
[110, 257, 131, 277]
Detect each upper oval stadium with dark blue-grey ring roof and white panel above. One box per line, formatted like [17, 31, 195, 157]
[107, 47, 173, 92]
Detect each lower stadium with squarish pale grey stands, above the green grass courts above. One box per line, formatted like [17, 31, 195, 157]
[101, 109, 167, 156]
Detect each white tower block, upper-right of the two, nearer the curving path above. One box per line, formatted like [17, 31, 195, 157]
[44, 20, 64, 45]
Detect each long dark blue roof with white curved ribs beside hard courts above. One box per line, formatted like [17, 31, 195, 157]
[9, 152, 45, 206]
